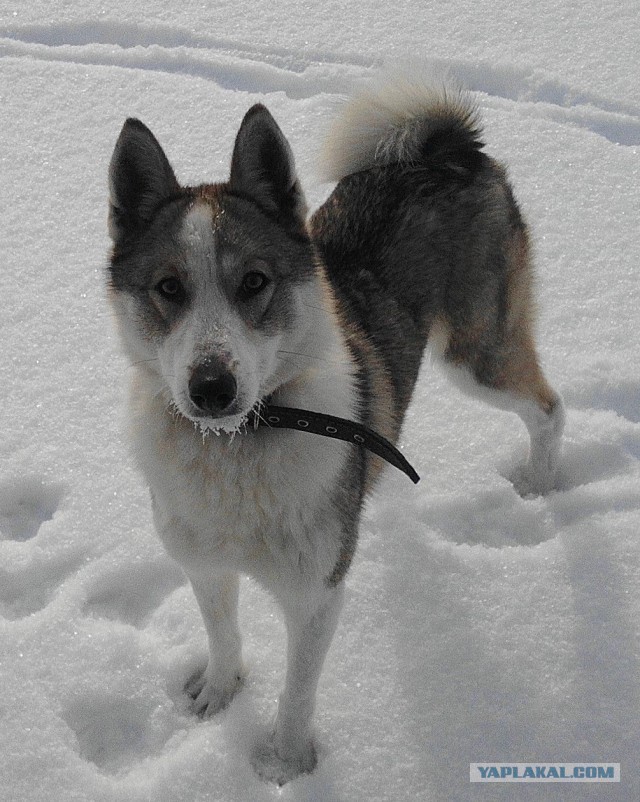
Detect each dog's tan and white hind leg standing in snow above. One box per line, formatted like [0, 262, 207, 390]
[429, 219, 564, 495]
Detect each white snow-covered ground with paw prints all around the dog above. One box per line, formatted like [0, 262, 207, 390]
[0, 0, 640, 802]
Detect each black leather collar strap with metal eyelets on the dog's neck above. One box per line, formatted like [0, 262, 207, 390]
[247, 402, 420, 484]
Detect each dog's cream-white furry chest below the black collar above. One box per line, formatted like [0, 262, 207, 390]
[133, 396, 345, 580]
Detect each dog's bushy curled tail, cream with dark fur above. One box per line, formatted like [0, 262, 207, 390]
[320, 71, 483, 181]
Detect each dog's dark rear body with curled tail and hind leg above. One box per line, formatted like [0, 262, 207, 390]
[311, 74, 564, 500]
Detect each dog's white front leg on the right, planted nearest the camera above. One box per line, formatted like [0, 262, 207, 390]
[254, 584, 344, 785]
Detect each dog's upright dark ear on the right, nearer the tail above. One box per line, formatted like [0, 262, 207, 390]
[229, 103, 307, 228]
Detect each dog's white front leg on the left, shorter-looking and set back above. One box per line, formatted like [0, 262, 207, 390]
[185, 573, 244, 717]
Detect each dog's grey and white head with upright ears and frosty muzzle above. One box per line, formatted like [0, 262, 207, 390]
[109, 105, 317, 431]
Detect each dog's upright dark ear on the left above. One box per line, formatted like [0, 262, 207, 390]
[109, 119, 180, 242]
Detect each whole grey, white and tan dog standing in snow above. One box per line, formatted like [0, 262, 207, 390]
[109, 73, 563, 784]
